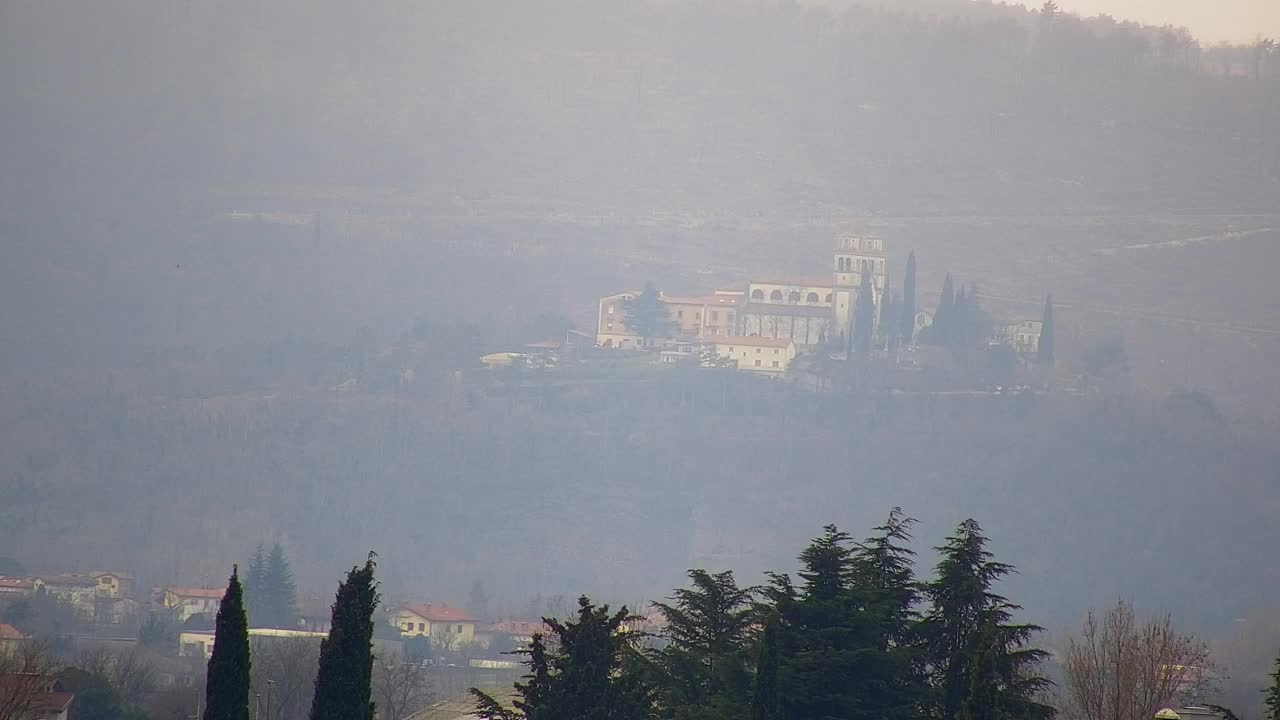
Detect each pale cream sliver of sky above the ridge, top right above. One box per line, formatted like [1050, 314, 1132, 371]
[1049, 0, 1280, 44]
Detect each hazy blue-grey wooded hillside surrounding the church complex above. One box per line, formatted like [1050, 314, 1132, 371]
[0, 0, 1280, 645]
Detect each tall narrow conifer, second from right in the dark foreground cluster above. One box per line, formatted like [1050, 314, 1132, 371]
[852, 507, 928, 720]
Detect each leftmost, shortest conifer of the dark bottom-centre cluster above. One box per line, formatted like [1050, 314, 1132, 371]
[471, 597, 653, 720]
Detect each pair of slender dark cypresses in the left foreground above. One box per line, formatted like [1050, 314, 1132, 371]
[204, 553, 379, 720]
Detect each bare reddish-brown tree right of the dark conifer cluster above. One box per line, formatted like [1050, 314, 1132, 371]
[1061, 602, 1216, 720]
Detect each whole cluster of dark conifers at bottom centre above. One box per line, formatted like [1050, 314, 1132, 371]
[472, 509, 1053, 720]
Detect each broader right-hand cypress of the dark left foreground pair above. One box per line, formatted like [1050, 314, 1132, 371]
[310, 552, 379, 720]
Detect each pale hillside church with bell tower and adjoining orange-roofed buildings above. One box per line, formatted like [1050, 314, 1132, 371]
[595, 234, 888, 353]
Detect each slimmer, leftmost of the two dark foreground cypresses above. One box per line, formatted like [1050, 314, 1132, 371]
[205, 568, 250, 720]
